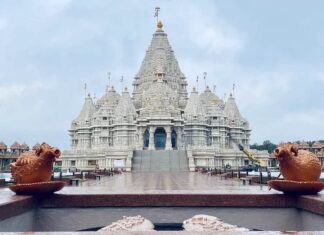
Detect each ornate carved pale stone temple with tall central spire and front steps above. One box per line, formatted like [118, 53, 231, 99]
[59, 21, 268, 171]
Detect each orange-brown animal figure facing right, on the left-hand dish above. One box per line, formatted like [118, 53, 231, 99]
[10, 143, 61, 184]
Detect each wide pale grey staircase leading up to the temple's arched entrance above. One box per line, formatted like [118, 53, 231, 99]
[132, 150, 189, 172]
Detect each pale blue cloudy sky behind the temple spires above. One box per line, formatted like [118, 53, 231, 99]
[0, 0, 324, 149]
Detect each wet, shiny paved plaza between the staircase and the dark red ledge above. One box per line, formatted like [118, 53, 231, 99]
[58, 172, 278, 194]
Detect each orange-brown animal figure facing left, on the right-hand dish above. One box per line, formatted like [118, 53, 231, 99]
[273, 144, 321, 182]
